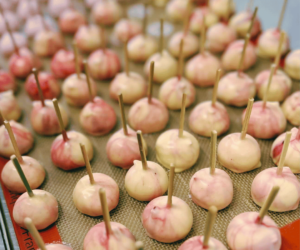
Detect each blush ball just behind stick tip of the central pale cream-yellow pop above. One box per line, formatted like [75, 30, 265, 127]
[158, 76, 196, 110]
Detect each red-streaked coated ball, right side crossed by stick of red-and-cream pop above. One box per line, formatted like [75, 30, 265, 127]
[30, 100, 69, 135]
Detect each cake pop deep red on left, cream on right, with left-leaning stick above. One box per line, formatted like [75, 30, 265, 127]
[51, 99, 94, 170]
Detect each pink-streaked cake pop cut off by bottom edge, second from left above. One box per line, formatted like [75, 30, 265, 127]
[83, 188, 136, 250]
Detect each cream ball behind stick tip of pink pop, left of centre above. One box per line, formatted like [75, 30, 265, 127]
[109, 72, 147, 104]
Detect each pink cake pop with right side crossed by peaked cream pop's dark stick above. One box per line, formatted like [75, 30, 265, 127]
[106, 94, 147, 169]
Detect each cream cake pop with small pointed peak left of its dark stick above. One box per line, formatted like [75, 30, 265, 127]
[125, 131, 168, 201]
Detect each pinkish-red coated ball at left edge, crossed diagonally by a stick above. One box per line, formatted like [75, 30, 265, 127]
[0, 121, 33, 158]
